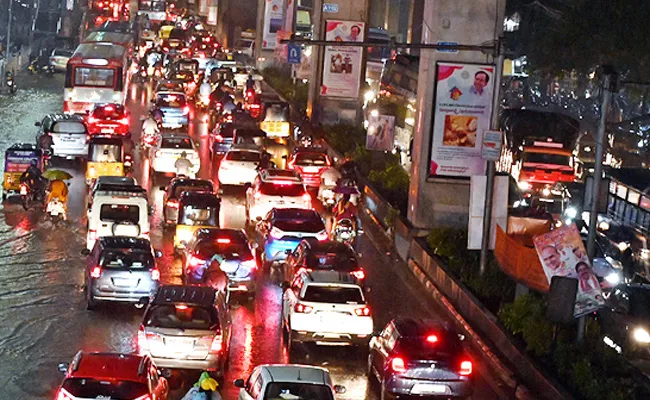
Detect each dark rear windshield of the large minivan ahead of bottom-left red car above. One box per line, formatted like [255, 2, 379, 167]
[145, 304, 219, 330]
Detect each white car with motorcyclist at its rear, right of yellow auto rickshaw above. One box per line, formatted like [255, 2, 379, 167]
[149, 133, 201, 175]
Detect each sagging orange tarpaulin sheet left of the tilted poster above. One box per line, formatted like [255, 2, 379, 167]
[494, 225, 549, 293]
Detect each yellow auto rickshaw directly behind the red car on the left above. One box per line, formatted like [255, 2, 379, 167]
[86, 137, 125, 185]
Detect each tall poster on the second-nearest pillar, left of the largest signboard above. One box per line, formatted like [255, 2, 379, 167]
[321, 20, 365, 98]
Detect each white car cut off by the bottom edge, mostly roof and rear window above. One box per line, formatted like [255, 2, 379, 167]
[235, 364, 345, 400]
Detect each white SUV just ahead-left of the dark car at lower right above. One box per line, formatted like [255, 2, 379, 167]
[282, 271, 373, 350]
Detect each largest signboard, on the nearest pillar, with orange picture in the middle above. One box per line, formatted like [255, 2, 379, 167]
[429, 62, 495, 177]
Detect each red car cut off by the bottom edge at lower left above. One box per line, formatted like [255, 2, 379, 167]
[55, 351, 169, 400]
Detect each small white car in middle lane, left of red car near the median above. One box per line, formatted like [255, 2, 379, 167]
[217, 146, 263, 185]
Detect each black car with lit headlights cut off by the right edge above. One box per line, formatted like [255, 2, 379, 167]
[598, 284, 650, 358]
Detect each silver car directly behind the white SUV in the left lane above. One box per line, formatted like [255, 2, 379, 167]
[82, 236, 162, 310]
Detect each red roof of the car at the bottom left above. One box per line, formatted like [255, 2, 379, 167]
[69, 351, 147, 382]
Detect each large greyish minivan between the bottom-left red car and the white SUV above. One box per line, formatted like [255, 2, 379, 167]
[138, 285, 230, 378]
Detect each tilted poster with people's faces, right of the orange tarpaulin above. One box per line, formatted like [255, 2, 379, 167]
[533, 224, 604, 318]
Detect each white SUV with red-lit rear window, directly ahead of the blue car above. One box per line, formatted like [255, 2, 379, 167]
[246, 169, 311, 223]
